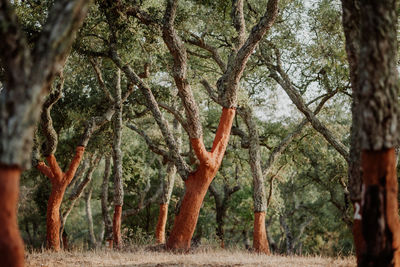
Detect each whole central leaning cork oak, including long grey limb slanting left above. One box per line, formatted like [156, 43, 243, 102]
[102, 0, 278, 253]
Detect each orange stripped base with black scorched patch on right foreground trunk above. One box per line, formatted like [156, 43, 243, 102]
[360, 148, 400, 266]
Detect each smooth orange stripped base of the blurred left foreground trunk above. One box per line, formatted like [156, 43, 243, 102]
[0, 169, 24, 267]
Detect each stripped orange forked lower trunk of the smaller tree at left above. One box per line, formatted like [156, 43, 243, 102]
[37, 146, 85, 251]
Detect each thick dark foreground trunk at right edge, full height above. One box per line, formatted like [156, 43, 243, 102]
[353, 0, 400, 266]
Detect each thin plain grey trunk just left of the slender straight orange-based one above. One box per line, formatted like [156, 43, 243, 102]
[101, 156, 112, 244]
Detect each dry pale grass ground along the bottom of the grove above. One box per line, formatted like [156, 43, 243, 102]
[25, 249, 356, 267]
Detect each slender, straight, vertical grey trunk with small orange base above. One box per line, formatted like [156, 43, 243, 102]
[113, 69, 124, 249]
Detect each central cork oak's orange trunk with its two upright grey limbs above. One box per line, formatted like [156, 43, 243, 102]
[162, 0, 278, 250]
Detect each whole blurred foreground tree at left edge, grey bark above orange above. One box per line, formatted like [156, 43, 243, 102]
[0, 0, 89, 267]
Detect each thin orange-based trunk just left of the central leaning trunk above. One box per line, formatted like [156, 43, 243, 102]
[155, 162, 176, 244]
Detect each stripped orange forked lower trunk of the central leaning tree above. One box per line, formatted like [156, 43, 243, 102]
[167, 108, 235, 250]
